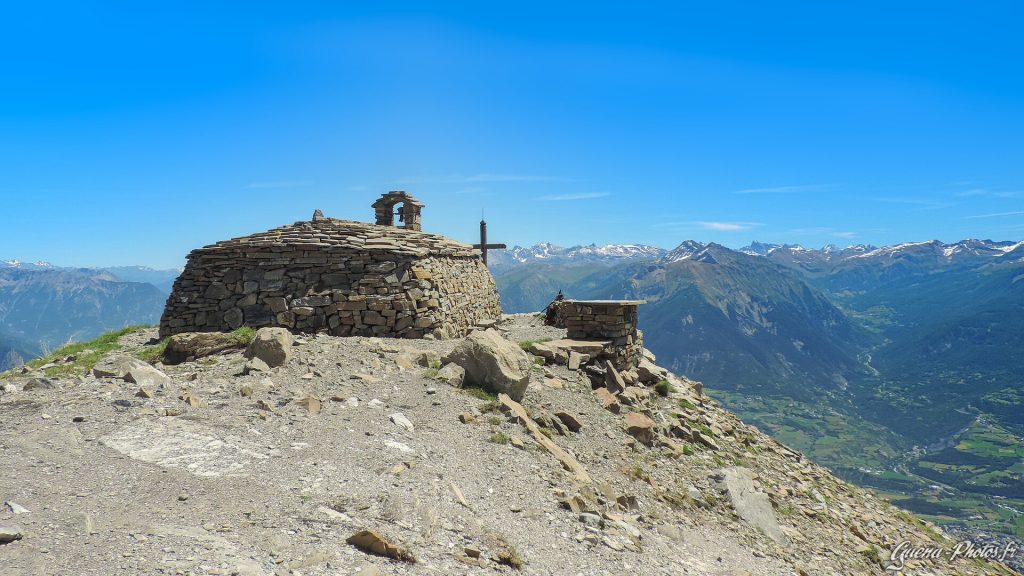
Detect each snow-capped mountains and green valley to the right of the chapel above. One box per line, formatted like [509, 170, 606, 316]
[496, 240, 1024, 529]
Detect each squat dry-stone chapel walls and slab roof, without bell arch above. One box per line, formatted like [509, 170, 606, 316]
[160, 217, 501, 338]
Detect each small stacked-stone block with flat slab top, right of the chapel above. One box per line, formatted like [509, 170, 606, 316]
[557, 300, 643, 369]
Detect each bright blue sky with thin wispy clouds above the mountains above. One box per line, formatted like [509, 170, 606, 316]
[0, 2, 1024, 266]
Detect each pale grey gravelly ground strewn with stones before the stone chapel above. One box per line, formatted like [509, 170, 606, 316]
[0, 315, 1007, 576]
